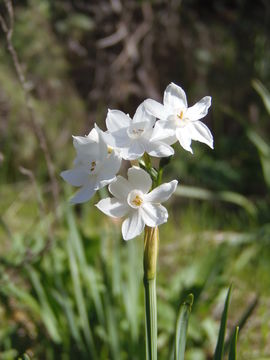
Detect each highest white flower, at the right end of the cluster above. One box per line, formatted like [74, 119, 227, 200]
[144, 83, 213, 153]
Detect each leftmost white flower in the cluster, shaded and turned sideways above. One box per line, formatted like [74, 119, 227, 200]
[61, 129, 121, 204]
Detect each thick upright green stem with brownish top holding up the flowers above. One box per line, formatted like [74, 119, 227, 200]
[144, 227, 159, 360]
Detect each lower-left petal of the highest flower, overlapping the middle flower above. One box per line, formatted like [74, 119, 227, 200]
[150, 120, 177, 145]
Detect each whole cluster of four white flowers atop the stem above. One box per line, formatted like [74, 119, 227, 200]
[61, 83, 213, 240]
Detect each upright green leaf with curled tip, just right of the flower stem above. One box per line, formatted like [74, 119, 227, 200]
[174, 294, 194, 360]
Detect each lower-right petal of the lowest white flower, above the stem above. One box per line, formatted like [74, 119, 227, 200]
[139, 203, 168, 227]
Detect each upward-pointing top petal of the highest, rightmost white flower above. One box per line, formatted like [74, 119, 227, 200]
[163, 83, 187, 110]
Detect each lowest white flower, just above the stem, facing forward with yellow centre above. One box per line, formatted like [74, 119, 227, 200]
[96, 166, 177, 240]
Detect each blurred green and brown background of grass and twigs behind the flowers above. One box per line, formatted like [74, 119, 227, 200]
[0, 0, 270, 360]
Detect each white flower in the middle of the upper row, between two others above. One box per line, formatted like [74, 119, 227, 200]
[100, 104, 174, 160]
